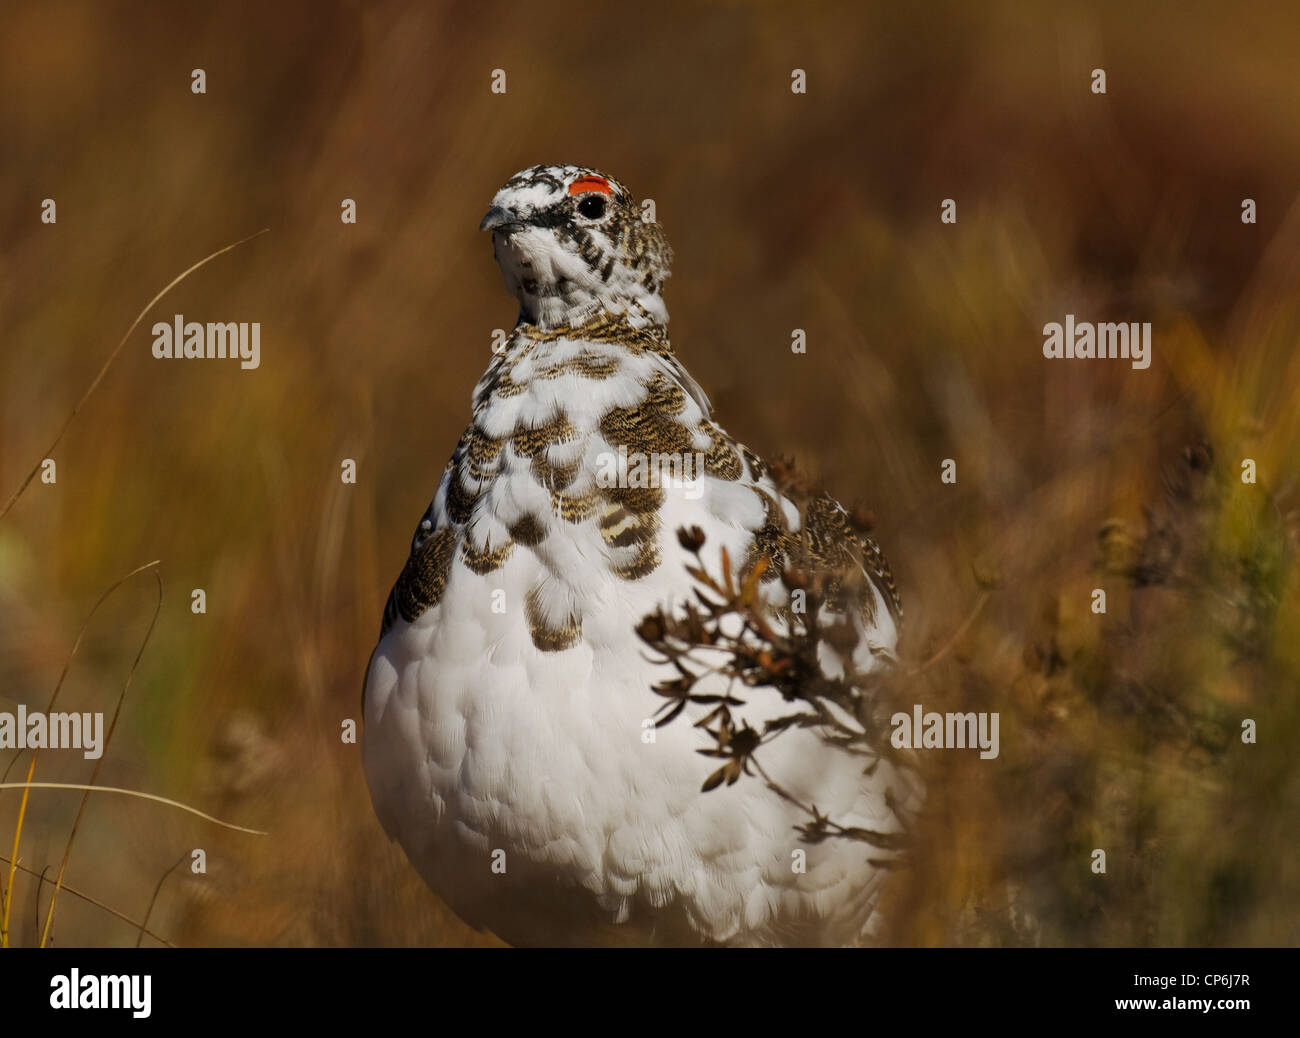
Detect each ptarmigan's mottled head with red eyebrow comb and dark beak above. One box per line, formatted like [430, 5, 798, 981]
[480, 165, 672, 328]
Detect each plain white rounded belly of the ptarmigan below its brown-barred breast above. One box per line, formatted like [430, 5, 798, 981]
[363, 523, 898, 944]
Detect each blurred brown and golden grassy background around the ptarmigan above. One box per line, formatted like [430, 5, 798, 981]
[0, 3, 1300, 944]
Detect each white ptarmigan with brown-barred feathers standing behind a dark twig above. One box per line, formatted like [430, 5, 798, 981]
[363, 165, 914, 944]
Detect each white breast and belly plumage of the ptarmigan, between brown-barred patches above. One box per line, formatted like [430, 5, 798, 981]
[363, 327, 907, 944]
